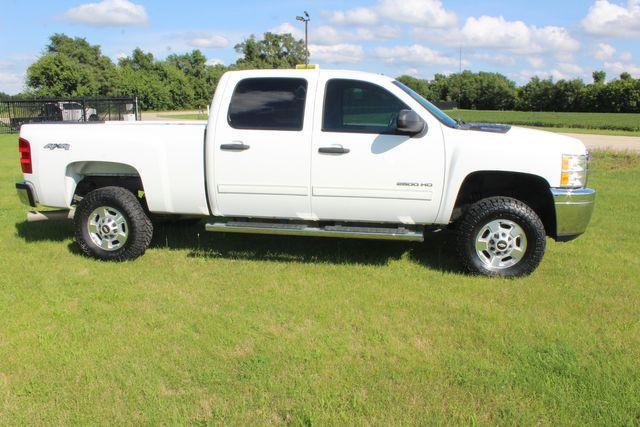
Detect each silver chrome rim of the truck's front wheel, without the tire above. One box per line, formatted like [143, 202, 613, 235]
[476, 219, 527, 270]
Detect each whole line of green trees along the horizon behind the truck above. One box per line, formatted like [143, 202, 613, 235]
[5, 33, 640, 113]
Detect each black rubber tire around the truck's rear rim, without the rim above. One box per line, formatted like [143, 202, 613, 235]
[73, 187, 153, 261]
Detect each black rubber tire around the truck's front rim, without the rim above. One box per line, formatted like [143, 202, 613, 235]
[456, 197, 546, 277]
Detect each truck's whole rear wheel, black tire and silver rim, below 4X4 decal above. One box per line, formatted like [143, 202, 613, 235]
[73, 187, 153, 261]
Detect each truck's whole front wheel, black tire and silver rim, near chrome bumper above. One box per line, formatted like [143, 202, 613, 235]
[457, 197, 546, 277]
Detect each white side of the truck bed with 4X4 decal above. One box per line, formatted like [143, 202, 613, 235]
[21, 122, 209, 215]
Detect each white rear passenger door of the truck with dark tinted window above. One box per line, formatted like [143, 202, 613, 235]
[213, 73, 316, 219]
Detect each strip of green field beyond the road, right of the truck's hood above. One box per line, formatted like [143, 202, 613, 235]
[446, 110, 640, 136]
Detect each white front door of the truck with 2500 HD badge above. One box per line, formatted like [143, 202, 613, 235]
[311, 78, 444, 224]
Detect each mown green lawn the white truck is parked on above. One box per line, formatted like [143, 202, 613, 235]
[0, 136, 640, 425]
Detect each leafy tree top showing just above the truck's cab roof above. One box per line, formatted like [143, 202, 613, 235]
[235, 33, 306, 69]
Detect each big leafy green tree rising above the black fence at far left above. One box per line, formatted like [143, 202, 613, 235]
[27, 34, 117, 96]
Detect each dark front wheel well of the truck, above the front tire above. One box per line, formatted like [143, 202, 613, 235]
[451, 171, 556, 237]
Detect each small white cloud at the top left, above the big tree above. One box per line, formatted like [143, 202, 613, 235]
[64, 0, 149, 27]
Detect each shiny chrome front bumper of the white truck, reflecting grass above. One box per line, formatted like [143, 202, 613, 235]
[551, 188, 596, 241]
